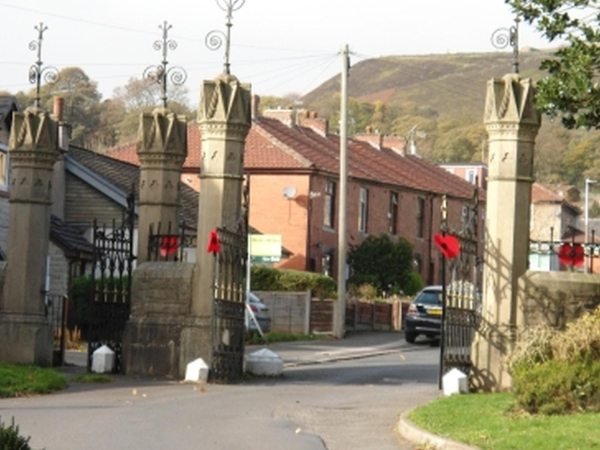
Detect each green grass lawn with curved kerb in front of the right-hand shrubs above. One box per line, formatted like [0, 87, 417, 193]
[409, 393, 600, 450]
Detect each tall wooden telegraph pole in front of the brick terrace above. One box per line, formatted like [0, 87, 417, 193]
[333, 44, 350, 339]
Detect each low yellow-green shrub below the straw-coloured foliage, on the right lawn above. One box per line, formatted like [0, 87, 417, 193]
[513, 359, 600, 414]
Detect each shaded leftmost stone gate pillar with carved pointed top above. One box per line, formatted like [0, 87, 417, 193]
[0, 107, 60, 366]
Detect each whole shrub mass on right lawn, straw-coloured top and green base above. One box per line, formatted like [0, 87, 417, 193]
[508, 307, 600, 414]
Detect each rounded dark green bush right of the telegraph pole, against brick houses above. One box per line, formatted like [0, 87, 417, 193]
[348, 234, 414, 293]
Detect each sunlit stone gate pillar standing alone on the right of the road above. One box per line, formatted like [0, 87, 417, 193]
[471, 74, 541, 391]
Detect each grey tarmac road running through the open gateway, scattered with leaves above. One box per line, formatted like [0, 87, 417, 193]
[0, 333, 439, 450]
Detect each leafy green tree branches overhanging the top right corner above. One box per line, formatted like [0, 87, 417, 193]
[506, 0, 600, 128]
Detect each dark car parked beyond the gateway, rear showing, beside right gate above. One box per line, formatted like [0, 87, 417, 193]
[404, 286, 443, 344]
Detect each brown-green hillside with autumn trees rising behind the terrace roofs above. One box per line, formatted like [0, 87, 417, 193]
[302, 49, 600, 187]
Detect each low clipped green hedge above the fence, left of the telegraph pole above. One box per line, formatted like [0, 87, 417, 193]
[251, 266, 337, 298]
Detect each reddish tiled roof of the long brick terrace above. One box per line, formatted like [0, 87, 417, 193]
[108, 117, 485, 199]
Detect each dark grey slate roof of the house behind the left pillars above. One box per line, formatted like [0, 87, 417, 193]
[68, 146, 198, 228]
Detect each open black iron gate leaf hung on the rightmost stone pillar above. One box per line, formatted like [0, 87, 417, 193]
[440, 188, 482, 385]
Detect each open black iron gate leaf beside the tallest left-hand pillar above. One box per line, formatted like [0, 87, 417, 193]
[210, 229, 248, 382]
